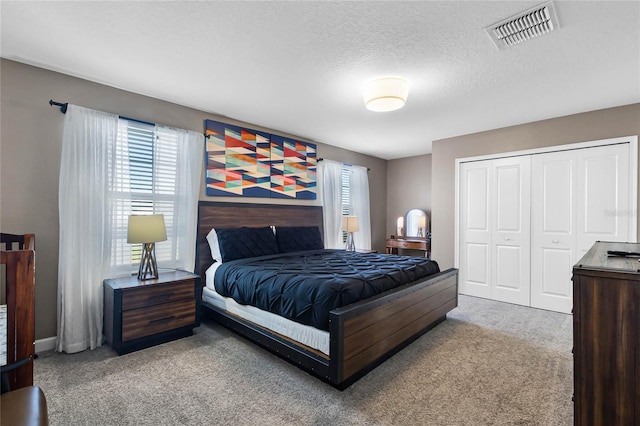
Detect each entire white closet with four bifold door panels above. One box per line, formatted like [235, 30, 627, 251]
[457, 137, 637, 313]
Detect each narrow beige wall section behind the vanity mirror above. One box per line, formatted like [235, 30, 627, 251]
[387, 154, 431, 240]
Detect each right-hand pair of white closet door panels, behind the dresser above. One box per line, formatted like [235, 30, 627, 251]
[531, 144, 635, 313]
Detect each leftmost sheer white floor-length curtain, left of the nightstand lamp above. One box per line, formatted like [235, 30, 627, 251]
[56, 105, 118, 353]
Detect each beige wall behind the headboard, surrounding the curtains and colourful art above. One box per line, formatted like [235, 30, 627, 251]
[0, 59, 387, 339]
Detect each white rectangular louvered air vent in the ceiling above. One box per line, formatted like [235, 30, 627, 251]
[485, 1, 559, 50]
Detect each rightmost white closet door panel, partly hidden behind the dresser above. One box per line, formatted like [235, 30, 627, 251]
[575, 144, 640, 256]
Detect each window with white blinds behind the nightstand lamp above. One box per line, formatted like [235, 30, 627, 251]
[110, 119, 179, 275]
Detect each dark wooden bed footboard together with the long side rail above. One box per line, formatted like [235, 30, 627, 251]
[203, 269, 458, 389]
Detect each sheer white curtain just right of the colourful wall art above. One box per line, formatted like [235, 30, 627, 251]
[319, 159, 344, 249]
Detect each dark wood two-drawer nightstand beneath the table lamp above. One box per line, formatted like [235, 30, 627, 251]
[104, 271, 200, 355]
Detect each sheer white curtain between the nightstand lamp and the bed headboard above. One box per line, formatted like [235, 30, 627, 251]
[156, 126, 204, 272]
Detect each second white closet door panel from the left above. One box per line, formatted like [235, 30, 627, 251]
[491, 155, 531, 306]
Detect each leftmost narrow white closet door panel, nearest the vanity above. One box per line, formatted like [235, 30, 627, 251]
[458, 160, 493, 298]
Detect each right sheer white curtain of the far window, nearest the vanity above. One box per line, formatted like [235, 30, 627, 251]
[349, 166, 371, 250]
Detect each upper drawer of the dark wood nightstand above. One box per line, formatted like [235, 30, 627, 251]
[122, 280, 195, 311]
